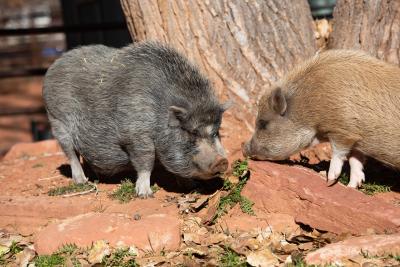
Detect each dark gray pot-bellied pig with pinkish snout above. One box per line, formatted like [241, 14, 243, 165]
[43, 42, 228, 197]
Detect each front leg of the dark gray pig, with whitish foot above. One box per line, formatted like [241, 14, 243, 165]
[127, 141, 155, 198]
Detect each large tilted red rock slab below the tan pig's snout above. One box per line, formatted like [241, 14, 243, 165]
[243, 161, 400, 234]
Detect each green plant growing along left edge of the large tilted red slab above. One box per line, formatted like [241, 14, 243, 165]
[212, 160, 254, 222]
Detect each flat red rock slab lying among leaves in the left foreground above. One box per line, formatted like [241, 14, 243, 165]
[35, 213, 181, 255]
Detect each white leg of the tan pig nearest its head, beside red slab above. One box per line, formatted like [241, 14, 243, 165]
[327, 139, 350, 186]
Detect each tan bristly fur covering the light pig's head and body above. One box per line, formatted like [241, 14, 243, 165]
[250, 50, 400, 168]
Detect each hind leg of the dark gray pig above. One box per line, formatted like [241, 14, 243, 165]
[49, 115, 88, 184]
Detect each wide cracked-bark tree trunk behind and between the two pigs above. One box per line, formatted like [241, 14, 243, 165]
[121, 0, 316, 130]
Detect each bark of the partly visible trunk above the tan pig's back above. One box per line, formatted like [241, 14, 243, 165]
[328, 0, 400, 65]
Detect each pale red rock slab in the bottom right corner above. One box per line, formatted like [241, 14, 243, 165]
[305, 233, 400, 265]
